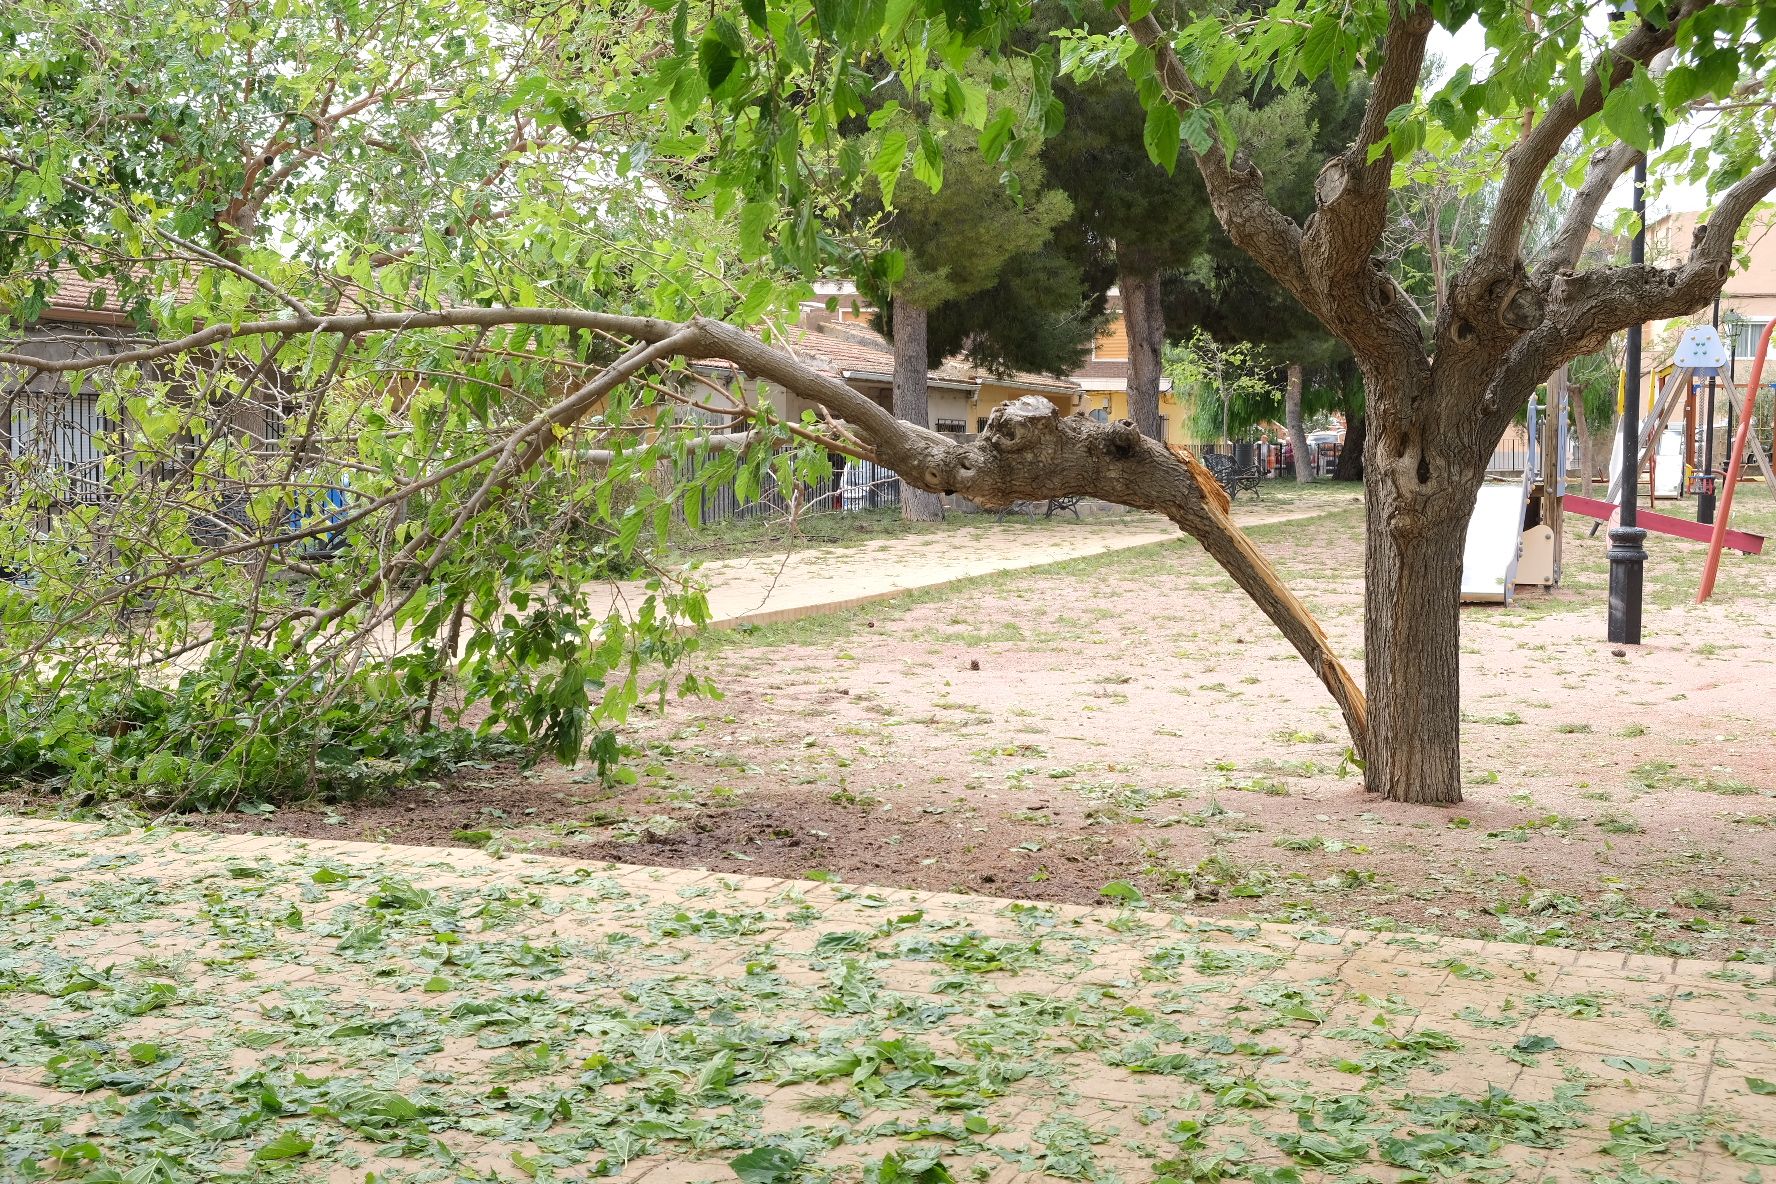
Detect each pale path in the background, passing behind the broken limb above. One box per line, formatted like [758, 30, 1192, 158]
[632, 506, 1341, 627]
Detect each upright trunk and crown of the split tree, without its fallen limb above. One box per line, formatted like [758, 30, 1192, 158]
[1094, 0, 1776, 802]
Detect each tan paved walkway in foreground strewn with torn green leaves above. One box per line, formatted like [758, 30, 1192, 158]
[0, 817, 1776, 1184]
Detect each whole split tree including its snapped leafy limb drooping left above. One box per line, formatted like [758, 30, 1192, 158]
[0, 0, 1776, 816]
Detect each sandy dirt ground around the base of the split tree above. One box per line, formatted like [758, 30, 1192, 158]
[169, 490, 1776, 962]
